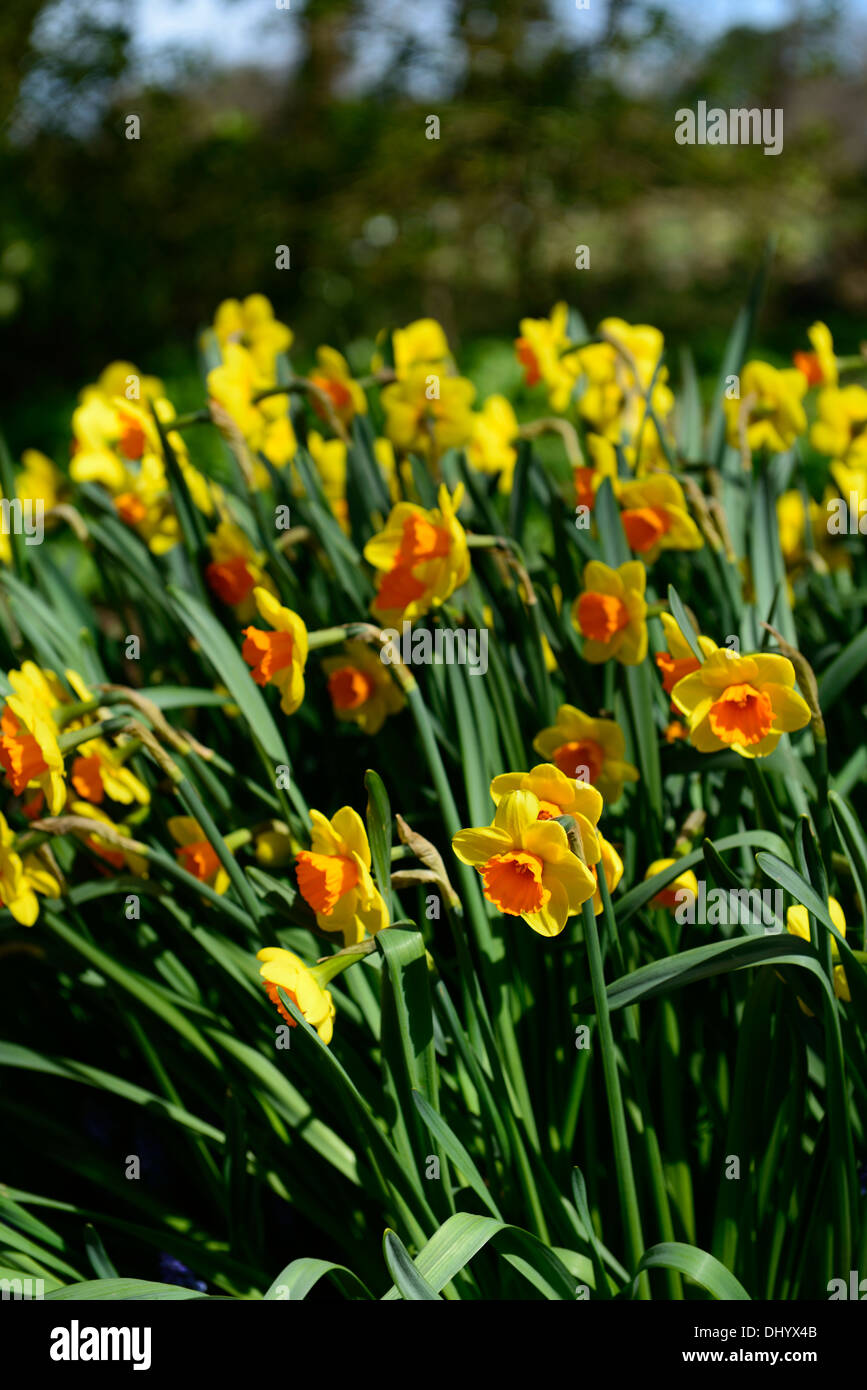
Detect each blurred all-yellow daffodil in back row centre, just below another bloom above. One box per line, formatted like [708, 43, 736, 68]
[381, 363, 475, 459]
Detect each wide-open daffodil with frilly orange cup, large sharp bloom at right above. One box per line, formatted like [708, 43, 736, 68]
[671, 649, 810, 758]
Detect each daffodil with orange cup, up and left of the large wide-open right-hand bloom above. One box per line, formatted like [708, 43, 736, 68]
[572, 560, 647, 666]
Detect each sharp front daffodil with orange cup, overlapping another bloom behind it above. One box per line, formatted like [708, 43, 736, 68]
[452, 791, 596, 937]
